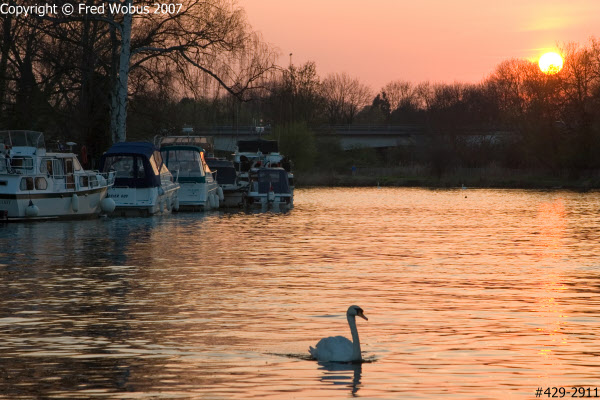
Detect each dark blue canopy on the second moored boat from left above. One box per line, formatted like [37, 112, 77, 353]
[100, 142, 169, 188]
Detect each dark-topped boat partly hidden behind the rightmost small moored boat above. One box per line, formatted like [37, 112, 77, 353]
[233, 138, 295, 207]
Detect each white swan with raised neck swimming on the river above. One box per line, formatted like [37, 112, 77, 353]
[308, 306, 368, 362]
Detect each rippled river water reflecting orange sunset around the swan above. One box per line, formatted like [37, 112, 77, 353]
[0, 189, 600, 399]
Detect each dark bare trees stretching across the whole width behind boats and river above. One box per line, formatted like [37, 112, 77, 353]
[0, 0, 600, 181]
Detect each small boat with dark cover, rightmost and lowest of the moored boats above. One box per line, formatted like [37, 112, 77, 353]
[244, 167, 293, 211]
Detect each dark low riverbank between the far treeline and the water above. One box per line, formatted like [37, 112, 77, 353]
[295, 166, 600, 191]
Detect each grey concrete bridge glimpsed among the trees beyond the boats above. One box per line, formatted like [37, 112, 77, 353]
[195, 125, 424, 151]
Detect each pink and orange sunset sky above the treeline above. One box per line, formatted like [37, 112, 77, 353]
[238, 0, 600, 90]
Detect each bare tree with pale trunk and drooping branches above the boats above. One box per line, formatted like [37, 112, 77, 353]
[106, 0, 275, 141]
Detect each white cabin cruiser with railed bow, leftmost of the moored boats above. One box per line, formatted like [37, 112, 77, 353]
[0, 130, 115, 221]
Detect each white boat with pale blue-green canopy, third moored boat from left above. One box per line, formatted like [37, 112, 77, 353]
[160, 136, 224, 211]
